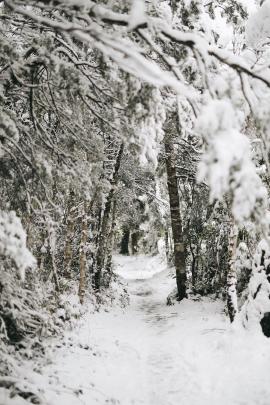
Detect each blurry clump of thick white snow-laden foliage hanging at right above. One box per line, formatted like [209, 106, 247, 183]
[198, 100, 268, 225]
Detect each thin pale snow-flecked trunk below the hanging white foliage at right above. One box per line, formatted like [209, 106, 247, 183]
[227, 221, 238, 322]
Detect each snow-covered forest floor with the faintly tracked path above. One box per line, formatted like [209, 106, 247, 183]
[0, 256, 270, 405]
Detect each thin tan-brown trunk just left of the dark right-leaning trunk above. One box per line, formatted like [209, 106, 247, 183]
[78, 203, 88, 304]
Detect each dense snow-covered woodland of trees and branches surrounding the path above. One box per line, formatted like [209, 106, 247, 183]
[0, 0, 270, 400]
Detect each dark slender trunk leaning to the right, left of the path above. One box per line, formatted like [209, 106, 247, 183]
[93, 143, 124, 290]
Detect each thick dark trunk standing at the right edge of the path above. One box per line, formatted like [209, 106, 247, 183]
[164, 136, 187, 301]
